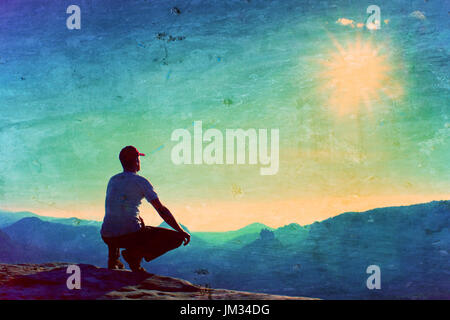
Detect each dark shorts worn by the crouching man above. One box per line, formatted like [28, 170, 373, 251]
[102, 226, 184, 261]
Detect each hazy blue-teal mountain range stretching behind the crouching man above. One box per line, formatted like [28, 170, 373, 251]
[0, 201, 450, 299]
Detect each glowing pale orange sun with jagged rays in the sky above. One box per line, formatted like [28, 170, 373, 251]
[321, 38, 398, 114]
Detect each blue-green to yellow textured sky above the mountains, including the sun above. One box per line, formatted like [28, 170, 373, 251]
[0, 0, 450, 231]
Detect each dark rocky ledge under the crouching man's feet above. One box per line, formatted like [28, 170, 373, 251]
[0, 263, 316, 300]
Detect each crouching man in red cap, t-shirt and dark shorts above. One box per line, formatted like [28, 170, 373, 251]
[100, 146, 191, 272]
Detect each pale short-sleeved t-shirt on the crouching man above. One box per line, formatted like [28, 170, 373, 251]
[100, 171, 158, 237]
